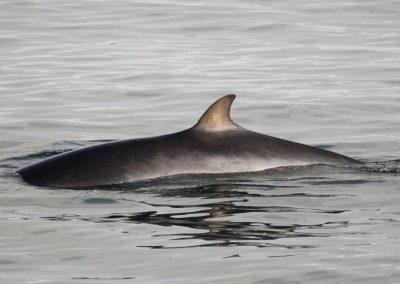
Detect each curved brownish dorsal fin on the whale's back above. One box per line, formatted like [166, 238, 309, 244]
[194, 95, 238, 131]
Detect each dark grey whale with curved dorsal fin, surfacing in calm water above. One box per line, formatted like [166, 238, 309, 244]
[18, 95, 361, 188]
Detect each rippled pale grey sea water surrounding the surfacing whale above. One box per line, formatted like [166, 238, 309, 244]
[0, 0, 400, 284]
